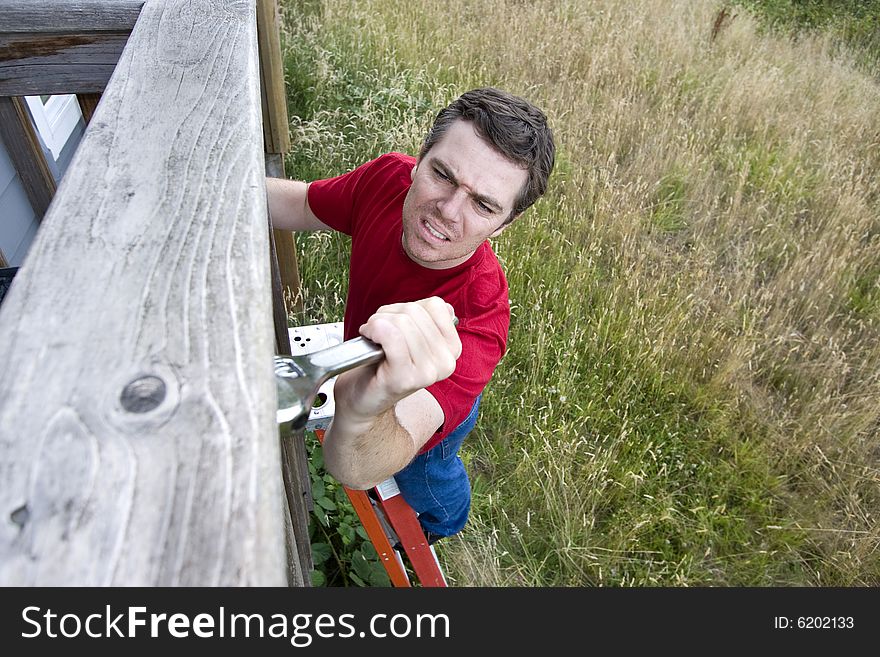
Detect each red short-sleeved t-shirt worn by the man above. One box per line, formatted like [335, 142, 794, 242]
[308, 153, 510, 452]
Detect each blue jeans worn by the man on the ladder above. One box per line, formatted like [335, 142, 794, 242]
[394, 395, 482, 537]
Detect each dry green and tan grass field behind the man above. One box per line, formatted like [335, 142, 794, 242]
[283, 0, 880, 586]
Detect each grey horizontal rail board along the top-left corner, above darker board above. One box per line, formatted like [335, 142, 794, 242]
[0, 0, 144, 33]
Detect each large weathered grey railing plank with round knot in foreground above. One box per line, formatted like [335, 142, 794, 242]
[0, 0, 287, 586]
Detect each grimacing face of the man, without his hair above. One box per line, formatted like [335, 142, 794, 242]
[403, 121, 528, 269]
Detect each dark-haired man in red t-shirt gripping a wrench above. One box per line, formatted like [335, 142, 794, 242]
[267, 88, 555, 542]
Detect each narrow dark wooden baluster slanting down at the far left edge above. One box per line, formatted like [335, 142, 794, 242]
[0, 96, 55, 218]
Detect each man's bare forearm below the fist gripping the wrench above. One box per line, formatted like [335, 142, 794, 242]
[323, 407, 416, 489]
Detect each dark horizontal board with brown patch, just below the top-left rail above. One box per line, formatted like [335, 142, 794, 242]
[0, 32, 128, 96]
